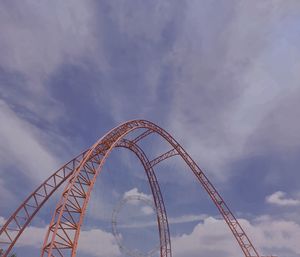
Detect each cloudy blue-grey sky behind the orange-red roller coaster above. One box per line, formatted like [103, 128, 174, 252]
[0, 0, 300, 257]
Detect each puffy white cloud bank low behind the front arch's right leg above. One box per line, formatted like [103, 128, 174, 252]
[172, 217, 300, 257]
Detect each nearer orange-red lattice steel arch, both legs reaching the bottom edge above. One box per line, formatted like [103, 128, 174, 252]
[41, 120, 259, 257]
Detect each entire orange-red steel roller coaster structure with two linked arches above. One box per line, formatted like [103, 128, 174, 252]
[0, 120, 276, 257]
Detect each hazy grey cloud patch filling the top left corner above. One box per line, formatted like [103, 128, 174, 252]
[0, 0, 99, 82]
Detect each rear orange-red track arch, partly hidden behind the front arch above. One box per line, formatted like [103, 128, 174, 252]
[0, 138, 173, 257]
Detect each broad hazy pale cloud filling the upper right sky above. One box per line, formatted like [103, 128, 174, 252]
[165, 1, 300, 180]
